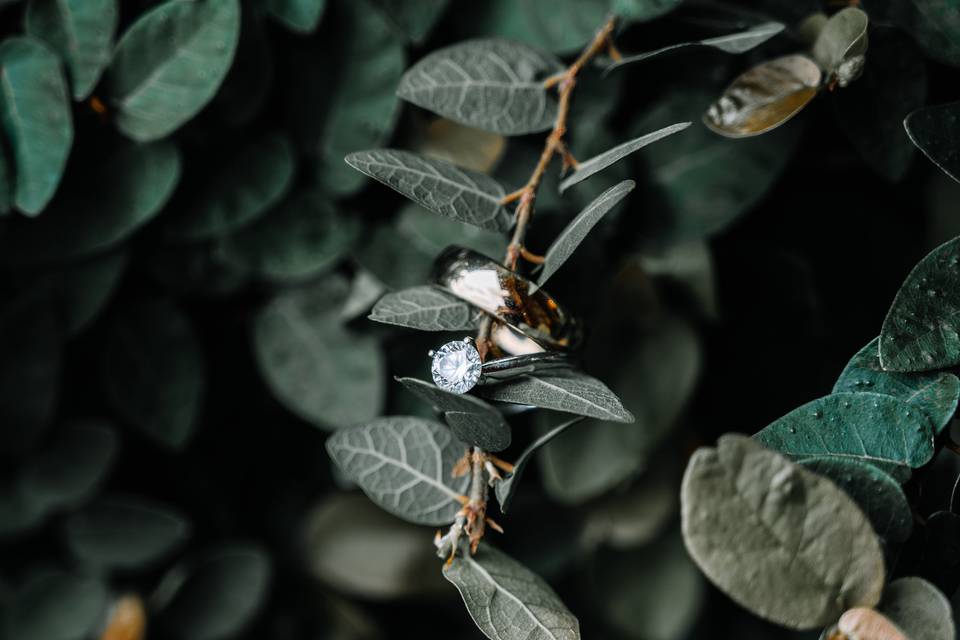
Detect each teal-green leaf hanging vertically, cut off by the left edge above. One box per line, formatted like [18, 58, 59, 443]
[0, 37, 73, 216]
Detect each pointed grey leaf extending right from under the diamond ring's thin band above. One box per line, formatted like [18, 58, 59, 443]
[474, 371, 633, 422]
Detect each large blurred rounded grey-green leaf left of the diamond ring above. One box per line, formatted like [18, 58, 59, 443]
[253, 281, 387, 429]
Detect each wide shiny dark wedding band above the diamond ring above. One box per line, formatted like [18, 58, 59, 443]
[433, 246, 582, 351]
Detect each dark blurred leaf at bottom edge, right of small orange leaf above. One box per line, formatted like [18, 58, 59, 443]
[159, 544, 273, 640]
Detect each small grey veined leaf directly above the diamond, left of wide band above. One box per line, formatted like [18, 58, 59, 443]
[370, 286, 478, 331]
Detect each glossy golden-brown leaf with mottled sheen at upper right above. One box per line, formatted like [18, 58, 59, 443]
[703, 54, 822, 138]
